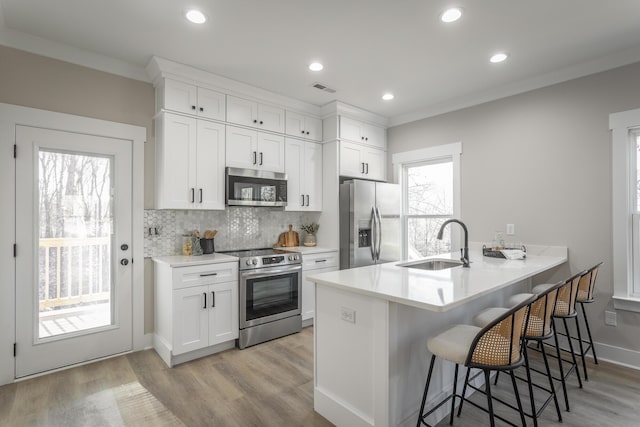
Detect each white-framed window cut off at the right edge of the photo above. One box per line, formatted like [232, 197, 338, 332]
[609, 109, 640, 311]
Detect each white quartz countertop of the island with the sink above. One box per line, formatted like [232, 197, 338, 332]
[308, 248, 567, 311]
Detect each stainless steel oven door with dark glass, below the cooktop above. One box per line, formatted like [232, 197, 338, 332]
[240, 265, 302, 329]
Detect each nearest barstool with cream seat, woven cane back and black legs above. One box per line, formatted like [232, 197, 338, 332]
[417, 296, 536, 427]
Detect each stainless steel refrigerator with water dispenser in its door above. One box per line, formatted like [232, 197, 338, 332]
[340, 179, 402, 269]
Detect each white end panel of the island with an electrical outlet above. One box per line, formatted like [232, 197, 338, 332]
[314, 284, 390, 427]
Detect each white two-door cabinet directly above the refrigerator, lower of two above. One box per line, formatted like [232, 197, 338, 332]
[340, 141, 387, 181]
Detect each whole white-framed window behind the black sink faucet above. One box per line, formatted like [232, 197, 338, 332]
[393, 143, 461, 259]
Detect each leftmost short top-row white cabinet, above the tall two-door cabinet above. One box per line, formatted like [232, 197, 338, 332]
[157, 79, 225, 121]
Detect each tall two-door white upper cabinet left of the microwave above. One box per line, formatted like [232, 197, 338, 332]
[156, 113, 225, 209]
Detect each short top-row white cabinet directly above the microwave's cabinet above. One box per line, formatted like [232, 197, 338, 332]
[227, 95, 285, 133]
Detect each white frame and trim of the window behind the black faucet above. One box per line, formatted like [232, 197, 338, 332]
[392, 142, 462, 259]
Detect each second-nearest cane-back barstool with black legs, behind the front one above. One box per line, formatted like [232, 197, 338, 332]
[474, 282, 564, 426]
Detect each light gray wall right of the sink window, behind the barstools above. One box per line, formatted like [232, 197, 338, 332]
[388, 63, 640, 351]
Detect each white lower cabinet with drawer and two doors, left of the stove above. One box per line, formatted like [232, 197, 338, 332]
[154, 262, 239, 366]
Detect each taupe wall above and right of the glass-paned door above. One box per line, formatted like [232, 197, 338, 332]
[0, 46, 155, 333]
